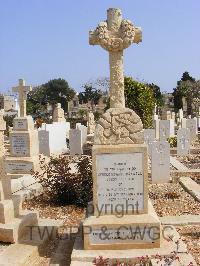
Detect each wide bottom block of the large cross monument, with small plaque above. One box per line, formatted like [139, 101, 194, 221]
[83, 202, 161, 250]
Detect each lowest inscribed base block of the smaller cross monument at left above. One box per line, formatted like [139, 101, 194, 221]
[5, 156, 39, 179]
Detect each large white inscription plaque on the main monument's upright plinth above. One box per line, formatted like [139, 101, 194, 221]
[96, 152, 144, 214]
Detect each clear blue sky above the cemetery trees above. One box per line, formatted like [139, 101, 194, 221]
[0, 0, 200, 92]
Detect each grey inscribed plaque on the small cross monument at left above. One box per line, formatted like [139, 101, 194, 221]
[11, 135, 28, 156]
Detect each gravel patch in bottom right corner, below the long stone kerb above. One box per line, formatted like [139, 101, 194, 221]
[176, 225, 200, 265]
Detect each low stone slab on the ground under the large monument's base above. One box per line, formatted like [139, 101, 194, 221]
[71, 226, 191, 266]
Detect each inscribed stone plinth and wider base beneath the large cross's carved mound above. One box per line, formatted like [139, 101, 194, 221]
[83, 144, 160, 250]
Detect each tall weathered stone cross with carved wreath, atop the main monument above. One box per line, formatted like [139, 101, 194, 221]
[89, 8, 142, 108]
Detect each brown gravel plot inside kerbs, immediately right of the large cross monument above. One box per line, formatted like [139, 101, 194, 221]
[149, 183, 200, 216]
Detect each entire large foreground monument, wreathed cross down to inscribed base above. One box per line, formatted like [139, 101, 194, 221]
[83, 8, 160, 250]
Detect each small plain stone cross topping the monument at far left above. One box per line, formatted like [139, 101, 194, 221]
[12, 79, 32, 117]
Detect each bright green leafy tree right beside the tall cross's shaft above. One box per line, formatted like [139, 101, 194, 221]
[124, 77, 156, 128]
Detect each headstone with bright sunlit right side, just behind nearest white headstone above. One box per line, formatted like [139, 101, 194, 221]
[159, 120, 174, 140]
